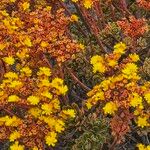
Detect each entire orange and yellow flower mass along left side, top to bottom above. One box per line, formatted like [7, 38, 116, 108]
[0, 0, 78, 150]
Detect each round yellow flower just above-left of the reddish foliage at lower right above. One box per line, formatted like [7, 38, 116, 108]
[103, 102, 117, 115]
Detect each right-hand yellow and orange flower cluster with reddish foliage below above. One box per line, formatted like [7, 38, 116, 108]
[86, 42, 150, 141]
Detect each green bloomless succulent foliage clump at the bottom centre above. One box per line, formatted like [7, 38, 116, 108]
[72, 115, 108, 150]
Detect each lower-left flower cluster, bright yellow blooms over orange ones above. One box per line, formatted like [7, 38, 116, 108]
[0, 67, 75, 150]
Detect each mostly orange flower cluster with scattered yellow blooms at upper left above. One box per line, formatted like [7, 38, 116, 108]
[0, 2, 84, 66]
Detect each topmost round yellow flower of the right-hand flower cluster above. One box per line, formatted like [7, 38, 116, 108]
[114, 42, 127, 54]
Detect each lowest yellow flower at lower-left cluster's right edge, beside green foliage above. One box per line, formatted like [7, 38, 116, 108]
[45, 132, 57, 146]
